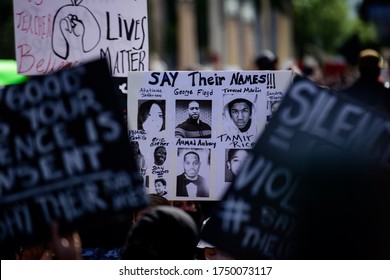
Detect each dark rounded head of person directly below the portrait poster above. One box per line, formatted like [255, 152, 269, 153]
[122, 206, 199, 260]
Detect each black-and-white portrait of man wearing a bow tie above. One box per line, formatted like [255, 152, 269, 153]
[176, 148, 211, 198]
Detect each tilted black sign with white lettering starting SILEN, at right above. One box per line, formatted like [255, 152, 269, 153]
[202, 79, 390, 259]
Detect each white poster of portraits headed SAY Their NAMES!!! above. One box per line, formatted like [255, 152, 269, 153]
[127, 71, 292, 200]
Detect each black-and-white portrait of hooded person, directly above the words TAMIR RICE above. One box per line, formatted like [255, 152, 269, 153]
[222, 94, 257, 135]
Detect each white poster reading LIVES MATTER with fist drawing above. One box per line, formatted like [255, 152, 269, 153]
[14, 0, 149, 77]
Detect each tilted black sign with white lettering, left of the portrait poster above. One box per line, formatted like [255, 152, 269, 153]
[0, 60, 146, 252]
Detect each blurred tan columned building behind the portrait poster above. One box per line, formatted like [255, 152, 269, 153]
[148, 0, 294, 70]
